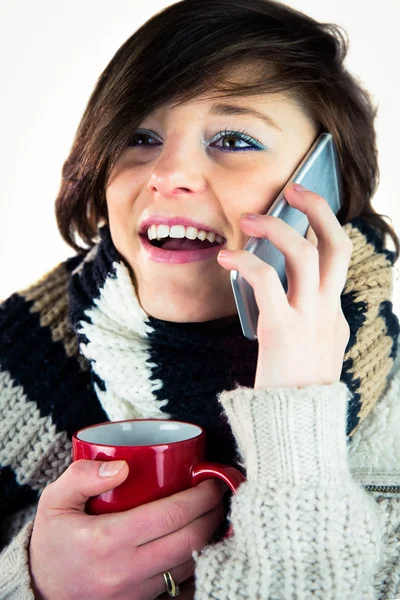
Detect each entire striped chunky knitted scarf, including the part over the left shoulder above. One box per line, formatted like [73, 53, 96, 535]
[0, 218, 400, 547]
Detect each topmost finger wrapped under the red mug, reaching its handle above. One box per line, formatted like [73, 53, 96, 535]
[104, 479, 225, 546]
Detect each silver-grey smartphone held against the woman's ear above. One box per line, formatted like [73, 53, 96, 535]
[230, 132, 343, 340]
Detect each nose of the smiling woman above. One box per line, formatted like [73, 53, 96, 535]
[147, 135, 206, 198]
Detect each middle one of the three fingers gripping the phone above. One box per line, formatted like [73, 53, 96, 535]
[241, 215, 319, 312]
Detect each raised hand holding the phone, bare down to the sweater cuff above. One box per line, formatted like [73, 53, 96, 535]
[218, 157, 353, 393]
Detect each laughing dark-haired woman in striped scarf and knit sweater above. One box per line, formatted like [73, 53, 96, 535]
[0, 0, 400, 600]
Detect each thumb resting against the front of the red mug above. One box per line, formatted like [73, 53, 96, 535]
[42, 459, 129, 512]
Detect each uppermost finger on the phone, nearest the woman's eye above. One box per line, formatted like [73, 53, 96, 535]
[285, 185, 353, 298]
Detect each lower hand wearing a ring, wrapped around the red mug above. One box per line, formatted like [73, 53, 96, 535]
[29, 460, 227, 600]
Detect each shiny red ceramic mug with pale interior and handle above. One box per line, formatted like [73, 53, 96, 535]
[72, 419, 245, 537]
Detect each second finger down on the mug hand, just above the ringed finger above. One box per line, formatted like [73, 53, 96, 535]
[135, 502, 225, 577]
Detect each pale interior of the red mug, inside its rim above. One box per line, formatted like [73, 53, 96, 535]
[76, 420, 201, 446]
